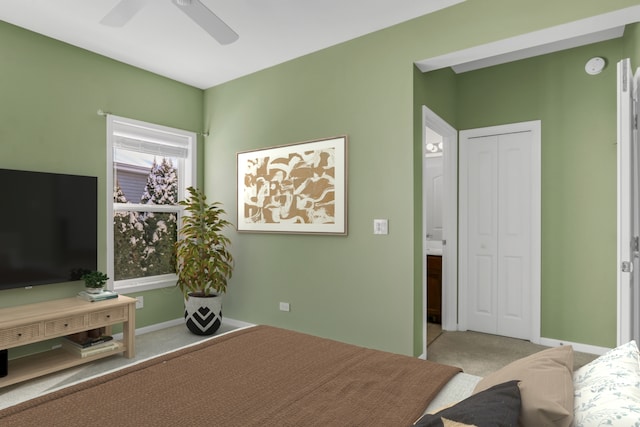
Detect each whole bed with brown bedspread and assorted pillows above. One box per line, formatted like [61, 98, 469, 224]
[0, 326, 640, 427]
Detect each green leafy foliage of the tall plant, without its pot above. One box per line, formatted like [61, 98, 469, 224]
[175, 187, 233, 298]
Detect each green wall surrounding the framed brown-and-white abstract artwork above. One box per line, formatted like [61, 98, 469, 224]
[205, 0, 636, 355]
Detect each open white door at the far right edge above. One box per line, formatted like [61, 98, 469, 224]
[617, 59, 640, 344]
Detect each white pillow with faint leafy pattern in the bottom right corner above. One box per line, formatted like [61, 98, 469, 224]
[573, 341, 640, 427]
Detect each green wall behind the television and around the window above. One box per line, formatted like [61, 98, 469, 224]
[0, 21, 204, 357]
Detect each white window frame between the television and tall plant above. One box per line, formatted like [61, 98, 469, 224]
[106, 114, 197, 293]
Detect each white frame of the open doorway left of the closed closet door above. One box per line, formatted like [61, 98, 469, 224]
[422, 105, 458, 355]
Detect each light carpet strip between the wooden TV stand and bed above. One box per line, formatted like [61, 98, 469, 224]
[0, 322, 236, 409]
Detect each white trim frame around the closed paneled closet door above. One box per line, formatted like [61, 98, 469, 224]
[458, 120, 542, 343]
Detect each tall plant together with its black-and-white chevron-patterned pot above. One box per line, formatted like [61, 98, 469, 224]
[175, 187, 233, 335]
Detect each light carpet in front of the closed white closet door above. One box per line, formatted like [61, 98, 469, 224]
[427, 331, 598, 377]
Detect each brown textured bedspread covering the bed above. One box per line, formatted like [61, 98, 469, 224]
[0, 326, 460, 427]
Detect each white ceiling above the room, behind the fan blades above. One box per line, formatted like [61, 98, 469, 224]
[0, 0, 464, 89]
